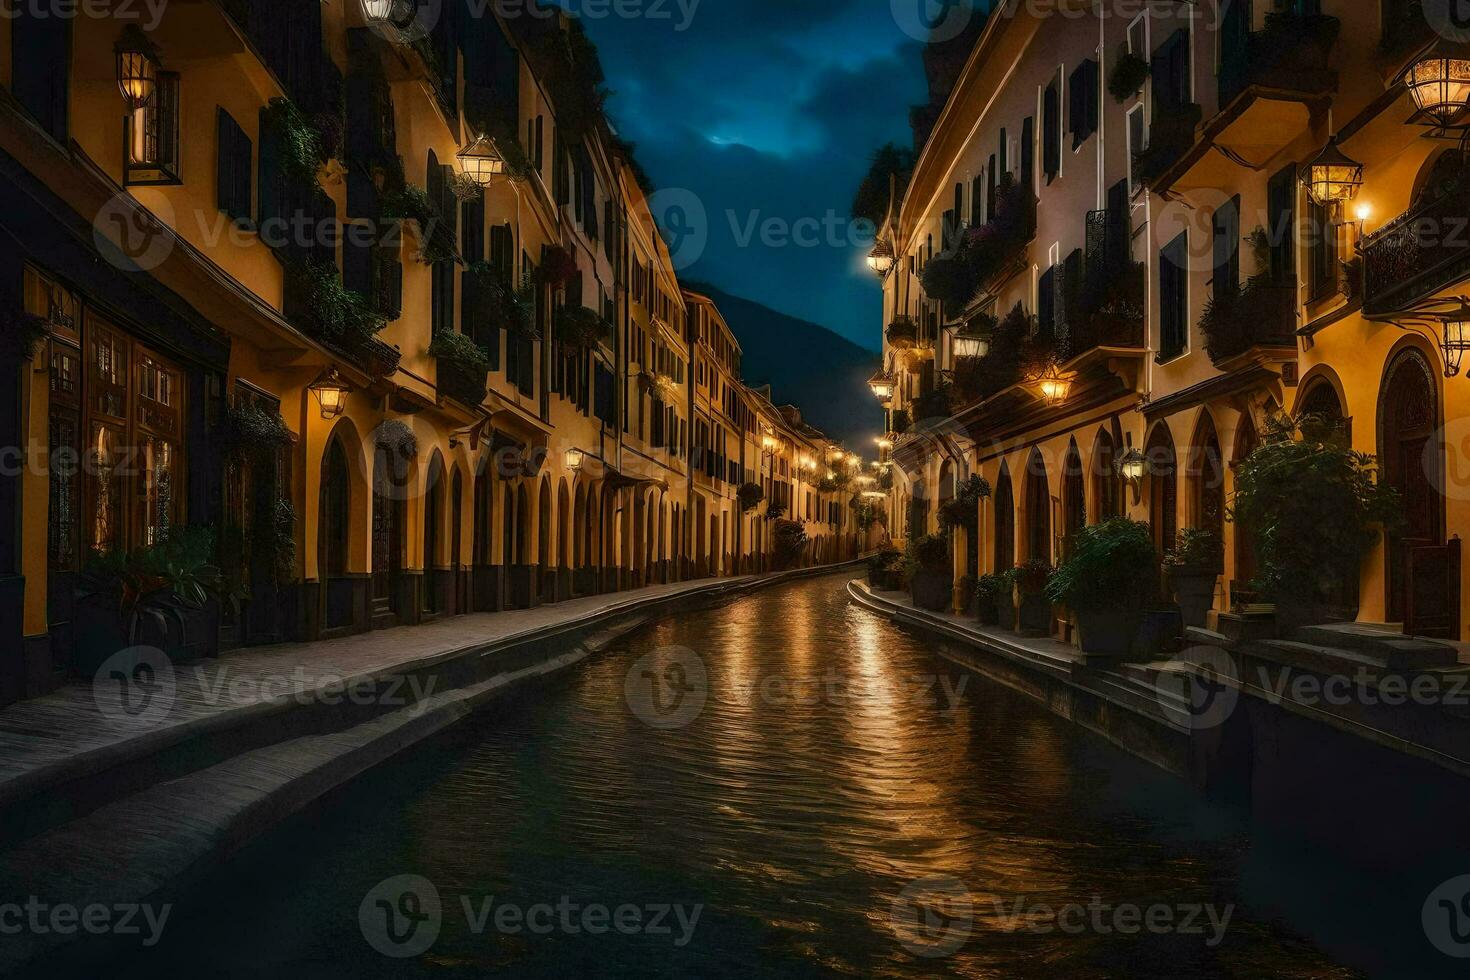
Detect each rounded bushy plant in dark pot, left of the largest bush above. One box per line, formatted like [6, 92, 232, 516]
[1047, 517, 1158, 657]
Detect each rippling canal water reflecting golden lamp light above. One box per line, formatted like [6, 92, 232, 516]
[109, 577, 1349, 977]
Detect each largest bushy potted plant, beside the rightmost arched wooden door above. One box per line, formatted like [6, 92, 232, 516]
[1227, 416, 1402, 630]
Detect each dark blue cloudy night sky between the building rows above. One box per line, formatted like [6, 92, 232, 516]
[559, 0, 925, 348]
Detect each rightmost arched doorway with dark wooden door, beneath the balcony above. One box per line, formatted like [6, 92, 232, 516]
[1379, 348, 1448, 623]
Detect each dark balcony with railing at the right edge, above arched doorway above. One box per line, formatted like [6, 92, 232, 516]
[1358, 187, 1470, 316]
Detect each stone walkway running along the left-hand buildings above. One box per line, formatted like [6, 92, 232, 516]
[0, 576, 772, 802]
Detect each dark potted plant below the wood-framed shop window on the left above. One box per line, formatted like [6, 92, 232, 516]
[76, 527, 222, 677]
